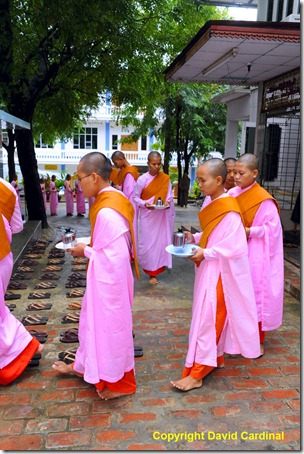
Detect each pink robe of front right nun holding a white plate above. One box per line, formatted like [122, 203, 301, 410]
[185, 194, 260, 367]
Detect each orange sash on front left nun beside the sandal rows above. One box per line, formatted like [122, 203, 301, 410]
[89, 191, 139, 279]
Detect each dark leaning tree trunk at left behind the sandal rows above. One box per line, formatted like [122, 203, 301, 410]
[15, 129, 48, 229]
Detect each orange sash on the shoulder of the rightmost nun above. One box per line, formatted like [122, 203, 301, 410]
[236, 183, 280, 227]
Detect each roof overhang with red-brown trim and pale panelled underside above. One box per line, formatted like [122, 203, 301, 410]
[164, 21, 300, 86]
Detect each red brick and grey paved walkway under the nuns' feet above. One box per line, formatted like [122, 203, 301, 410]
[0, 204, 300, 451]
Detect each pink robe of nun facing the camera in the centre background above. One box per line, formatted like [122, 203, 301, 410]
[134, 172, 175, 271]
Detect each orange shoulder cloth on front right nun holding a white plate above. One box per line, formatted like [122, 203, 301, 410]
[198, 197, 242, 248]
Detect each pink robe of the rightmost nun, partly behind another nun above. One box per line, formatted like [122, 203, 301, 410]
[229, 185, 284, 331]
